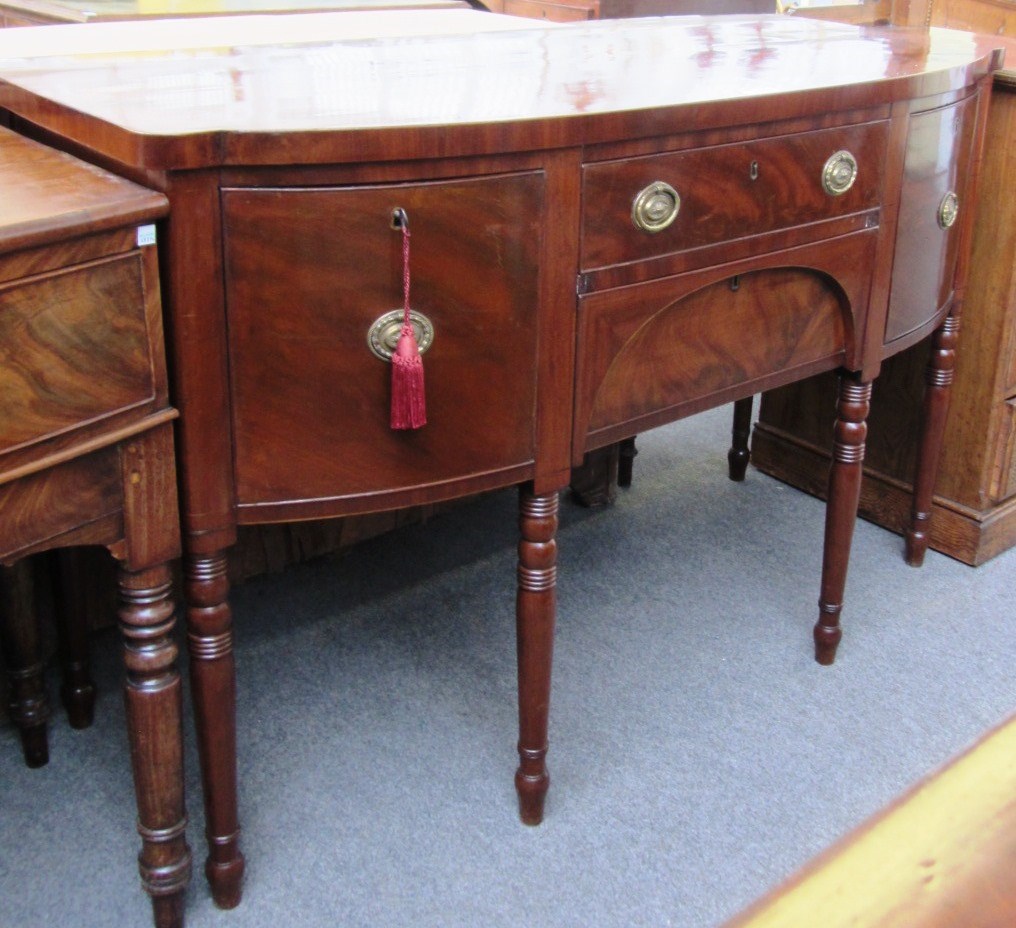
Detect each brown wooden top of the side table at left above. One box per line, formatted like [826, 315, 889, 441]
[0, 127, 168, 254]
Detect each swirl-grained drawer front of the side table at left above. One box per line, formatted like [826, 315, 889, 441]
[0, 252, 154, 452]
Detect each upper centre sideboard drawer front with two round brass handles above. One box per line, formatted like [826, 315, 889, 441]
[581, 122, 888, 270]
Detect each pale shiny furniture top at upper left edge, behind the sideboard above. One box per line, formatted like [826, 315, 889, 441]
[0, 0, 469, 23]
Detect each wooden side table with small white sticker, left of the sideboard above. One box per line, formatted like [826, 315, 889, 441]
[0, 129, 190, 924]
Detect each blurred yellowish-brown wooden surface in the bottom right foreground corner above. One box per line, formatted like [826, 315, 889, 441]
[726, 718, 1016, 928]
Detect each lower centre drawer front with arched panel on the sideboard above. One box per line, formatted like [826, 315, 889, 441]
[573, 232, 877, 450]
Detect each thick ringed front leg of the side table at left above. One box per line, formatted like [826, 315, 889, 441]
[119, 565, 191, 928]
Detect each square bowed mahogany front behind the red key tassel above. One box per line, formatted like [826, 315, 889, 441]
[223, 172, 544, 508]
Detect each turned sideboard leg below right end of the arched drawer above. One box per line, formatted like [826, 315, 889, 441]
[815, 375, 872, 665]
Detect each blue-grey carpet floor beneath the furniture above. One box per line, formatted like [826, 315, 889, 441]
[0, 409, 1016, 928]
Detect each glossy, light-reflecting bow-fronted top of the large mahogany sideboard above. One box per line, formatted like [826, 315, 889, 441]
[0, 10, 1005, 168]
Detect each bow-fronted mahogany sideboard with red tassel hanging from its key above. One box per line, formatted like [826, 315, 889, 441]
[0, 11, 1001, 922]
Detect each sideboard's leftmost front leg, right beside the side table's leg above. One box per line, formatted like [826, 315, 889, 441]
[185, 552, 244, 909]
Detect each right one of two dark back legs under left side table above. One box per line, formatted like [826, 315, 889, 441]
[54, 549, 96, 729]
